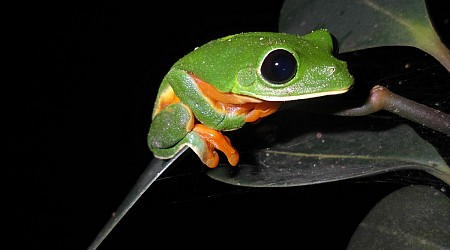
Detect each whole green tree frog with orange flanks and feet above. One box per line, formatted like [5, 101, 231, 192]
[147, 29, 354, 168]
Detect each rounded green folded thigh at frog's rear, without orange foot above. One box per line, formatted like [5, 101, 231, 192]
[147, 103, 194, 151]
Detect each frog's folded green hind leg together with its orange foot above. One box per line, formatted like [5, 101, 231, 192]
[147, 102, 239, 168]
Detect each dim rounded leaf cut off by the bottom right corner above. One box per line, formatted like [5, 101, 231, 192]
[347, 185, 450, 250]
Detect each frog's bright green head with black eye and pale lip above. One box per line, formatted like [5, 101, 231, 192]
[232, 30, 353, 101]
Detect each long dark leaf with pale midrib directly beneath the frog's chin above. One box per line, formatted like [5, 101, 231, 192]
[208, 110, 450, 187]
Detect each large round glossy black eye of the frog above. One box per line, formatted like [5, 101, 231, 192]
[261, 49, 297, 84]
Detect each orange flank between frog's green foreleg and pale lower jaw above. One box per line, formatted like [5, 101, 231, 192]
[190, 73, 282, 122]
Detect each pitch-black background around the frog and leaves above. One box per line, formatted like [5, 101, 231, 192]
[1, 0, 449, 249]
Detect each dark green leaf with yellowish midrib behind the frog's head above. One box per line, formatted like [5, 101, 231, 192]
[279, 0, 450, 71]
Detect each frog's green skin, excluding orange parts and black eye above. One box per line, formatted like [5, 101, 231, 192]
[148, 30, 353, 168]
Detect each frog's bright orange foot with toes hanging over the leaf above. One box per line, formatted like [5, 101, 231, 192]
[193, 124, 239, 168]
